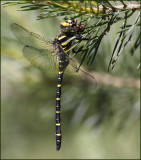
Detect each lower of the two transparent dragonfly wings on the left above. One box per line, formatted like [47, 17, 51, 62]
[23, 46, 57, 71]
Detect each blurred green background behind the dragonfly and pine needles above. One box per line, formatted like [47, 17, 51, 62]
[1, 3, 140, 159]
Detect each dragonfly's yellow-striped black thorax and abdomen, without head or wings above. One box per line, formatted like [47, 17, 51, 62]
[54, 34, 72, 151]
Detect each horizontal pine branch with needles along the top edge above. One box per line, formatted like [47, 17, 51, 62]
[3, 1, 141, 15]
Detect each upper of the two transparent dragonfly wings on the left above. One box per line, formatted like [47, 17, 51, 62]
[10, 23, 53, 50]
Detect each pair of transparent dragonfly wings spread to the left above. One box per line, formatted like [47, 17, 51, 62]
[10, 23, 57, 71]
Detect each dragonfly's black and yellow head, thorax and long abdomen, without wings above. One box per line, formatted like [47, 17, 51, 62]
[53, 20, 84, 151]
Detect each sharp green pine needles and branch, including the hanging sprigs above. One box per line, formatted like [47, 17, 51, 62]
[4, 1, 140, 71]
